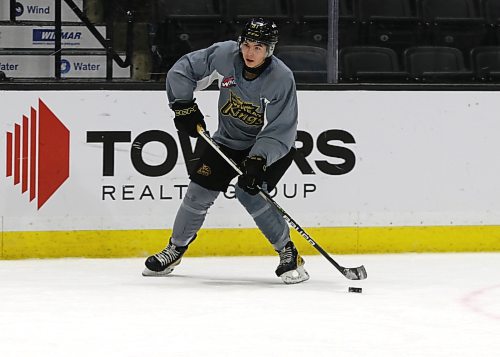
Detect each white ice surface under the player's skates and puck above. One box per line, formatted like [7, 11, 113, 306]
[0, 253, 500, 357]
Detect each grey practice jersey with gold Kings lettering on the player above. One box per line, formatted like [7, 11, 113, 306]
[167, 41, 298, 165]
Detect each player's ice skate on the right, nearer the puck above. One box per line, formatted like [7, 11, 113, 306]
[276, 241, 309, 284]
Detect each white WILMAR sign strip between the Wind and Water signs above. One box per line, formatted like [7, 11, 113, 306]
[0, 25, 106, 49]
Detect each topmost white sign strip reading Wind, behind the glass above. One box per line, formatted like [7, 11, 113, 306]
[0, 0, 83, 22]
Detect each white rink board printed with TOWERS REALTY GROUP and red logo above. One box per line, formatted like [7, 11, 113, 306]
[0, 91, 500, 231]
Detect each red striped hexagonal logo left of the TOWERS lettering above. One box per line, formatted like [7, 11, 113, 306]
[6, 99, 69, 209]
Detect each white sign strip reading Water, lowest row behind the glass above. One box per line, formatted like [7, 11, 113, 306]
[0, 54, 130, 78]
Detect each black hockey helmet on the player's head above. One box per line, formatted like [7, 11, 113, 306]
[238, 17, 278, 57]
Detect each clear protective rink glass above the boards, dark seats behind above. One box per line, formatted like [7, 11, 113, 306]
[0, 0, 500, 84]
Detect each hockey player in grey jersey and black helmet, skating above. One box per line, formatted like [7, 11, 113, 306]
[143, 18, 309, 284]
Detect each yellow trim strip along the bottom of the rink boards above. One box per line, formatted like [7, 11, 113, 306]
[0, 226, 500, 259]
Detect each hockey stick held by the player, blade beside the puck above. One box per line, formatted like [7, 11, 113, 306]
[197, 125, 368, 280]
